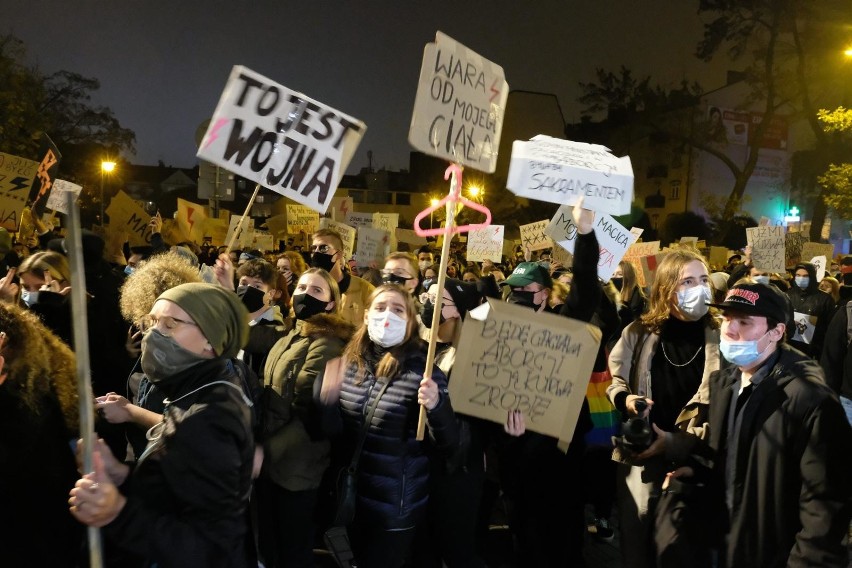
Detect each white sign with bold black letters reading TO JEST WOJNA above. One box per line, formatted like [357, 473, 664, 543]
[198, 65, 367, 213]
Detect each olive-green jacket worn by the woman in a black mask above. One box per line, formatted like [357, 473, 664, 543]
[263, 314, 355, 491]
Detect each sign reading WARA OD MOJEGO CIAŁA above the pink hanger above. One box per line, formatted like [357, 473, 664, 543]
[408, 32, 509, 173]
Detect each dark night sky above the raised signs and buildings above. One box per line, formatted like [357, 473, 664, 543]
[5, 0, 725, 171]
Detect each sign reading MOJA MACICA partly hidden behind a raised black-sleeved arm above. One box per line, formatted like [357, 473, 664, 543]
[545, 205, 637, 280]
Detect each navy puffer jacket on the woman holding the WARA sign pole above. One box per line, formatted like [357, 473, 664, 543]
[340, 349, 458, 529]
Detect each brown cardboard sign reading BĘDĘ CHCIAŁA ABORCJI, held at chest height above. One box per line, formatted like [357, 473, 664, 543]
[449, 298, 601, 440]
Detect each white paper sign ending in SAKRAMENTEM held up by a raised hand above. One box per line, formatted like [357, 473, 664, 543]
[506, 135, 633, 215]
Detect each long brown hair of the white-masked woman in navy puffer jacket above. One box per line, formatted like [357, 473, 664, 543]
[343, 284, 422, 383]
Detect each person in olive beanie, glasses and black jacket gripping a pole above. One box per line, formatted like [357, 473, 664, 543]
[68, 283, 254, 567]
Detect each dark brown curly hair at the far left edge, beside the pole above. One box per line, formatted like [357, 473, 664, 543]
[0, 302, 80, 437]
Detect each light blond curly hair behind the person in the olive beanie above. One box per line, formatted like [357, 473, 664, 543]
[119, 251, 201, 323]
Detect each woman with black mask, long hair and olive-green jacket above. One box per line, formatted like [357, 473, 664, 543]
[257, 268, 355, 568]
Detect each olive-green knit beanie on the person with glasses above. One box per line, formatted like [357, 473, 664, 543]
[158, 282, 249, 359]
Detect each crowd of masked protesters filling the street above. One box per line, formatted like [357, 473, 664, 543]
[0, 202, 852, 568]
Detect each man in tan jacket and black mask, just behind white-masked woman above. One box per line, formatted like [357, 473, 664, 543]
[311, 229, 375, 329]
